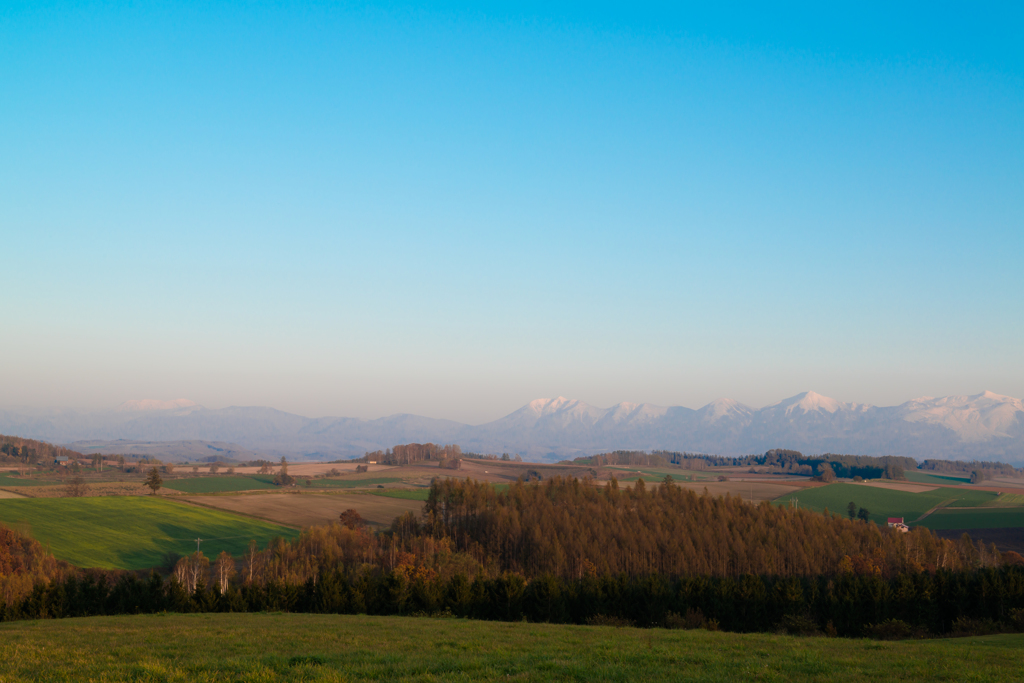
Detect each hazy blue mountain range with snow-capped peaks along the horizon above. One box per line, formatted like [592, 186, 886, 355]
[0, 391, 1024, 462]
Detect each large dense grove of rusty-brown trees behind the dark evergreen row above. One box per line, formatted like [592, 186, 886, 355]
[425, 477, 983, 577]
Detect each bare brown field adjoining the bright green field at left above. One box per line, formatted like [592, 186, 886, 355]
[175, 493, 423, 528]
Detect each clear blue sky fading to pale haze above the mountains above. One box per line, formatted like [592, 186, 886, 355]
[0, 1, 1024, 424]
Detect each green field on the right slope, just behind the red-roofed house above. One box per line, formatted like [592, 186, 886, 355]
[775, 482, 996, 528]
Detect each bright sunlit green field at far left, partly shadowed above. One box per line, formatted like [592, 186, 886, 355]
[0, 496, 298, 569]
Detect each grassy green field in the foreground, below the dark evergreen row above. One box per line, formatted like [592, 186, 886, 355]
[0, 613, 1024, 683]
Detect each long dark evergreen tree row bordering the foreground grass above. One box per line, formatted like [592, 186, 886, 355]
[6, 565, 1024, 636]
